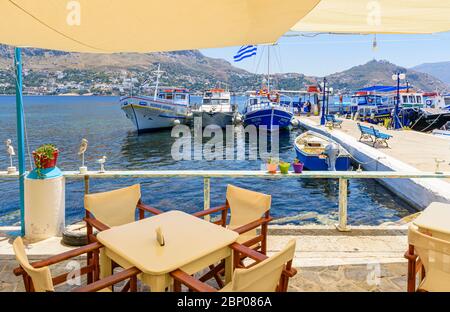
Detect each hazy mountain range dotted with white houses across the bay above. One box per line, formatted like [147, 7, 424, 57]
[0, 45, 448, 95]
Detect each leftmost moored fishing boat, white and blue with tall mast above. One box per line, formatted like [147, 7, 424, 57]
[120, 67, 190, 133]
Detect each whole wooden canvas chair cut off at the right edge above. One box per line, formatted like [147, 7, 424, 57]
[405, 225, 450, 292]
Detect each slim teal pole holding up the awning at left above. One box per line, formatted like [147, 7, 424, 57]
[14, 48, 25, 236]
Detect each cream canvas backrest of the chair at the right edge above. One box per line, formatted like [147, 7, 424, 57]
[408, 225, 450, 291]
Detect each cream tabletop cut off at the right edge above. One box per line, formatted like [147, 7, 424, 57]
[413, 202, 450, 241]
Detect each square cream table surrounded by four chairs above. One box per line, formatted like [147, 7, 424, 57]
[97, 211, 239, 291]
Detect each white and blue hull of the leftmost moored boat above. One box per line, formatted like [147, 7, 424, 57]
[121, 97, 188, 132]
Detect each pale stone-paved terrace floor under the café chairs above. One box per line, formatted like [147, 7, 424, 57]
[0, 226, 407, 292]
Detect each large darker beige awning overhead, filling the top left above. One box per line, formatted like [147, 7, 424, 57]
[0, 0, 319, 53]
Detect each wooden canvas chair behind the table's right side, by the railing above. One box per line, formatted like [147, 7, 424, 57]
[194, 184, 272, 287]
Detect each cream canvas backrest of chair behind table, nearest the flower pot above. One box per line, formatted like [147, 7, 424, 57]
[84, 184, 141, 227]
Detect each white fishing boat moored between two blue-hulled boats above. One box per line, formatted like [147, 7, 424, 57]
[192, 89, 240, 128]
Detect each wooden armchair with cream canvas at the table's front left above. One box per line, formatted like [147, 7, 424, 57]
[13, 237, 140, 292]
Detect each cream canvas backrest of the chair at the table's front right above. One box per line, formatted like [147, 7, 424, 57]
[231, 239, 295, 292]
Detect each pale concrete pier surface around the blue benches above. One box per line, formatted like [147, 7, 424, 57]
[297, 116, 450, 172]
